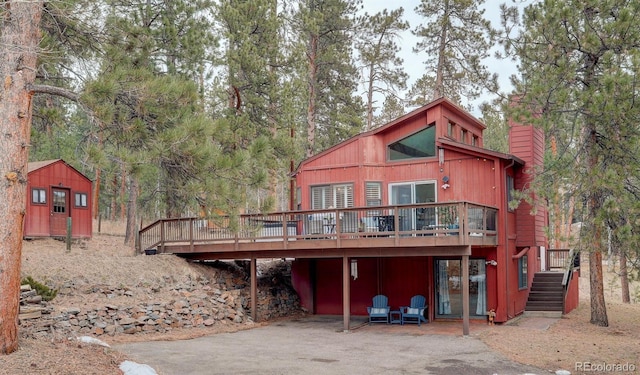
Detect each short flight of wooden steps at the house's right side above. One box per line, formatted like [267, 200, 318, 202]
[525, 272, 564, 316]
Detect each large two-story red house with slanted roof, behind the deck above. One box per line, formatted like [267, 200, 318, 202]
[292, 98, 577, 322]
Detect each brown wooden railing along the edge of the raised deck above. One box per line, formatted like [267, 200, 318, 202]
[138, 202, 498, 251]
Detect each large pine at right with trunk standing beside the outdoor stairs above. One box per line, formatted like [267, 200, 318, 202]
[507, 0, 640, 326]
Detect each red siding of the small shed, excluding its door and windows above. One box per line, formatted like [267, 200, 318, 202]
[23, 160, 93, 238]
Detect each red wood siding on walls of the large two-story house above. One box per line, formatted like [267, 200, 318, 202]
[294, 100, 546, 322]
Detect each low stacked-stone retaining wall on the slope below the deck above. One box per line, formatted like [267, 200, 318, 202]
[20, 265, 300, 337]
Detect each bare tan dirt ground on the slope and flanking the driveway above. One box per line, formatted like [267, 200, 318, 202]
[0, 223, 640, 375]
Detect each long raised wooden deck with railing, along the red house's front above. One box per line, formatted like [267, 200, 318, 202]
[138, 202, 497, 260]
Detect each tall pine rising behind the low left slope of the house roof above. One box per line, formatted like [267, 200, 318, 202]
[294, 0, 364, 156]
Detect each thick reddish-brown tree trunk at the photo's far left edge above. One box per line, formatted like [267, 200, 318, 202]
[0, 1, 42, 354]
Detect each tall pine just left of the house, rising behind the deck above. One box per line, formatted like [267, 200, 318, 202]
[216, 0, 295, 212]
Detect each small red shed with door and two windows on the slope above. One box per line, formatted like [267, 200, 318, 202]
[23, 159, 93, 238]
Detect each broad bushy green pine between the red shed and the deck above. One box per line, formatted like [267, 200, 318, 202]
[83, 1, 222, 220]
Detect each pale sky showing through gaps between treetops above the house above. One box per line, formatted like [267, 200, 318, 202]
[362, 0, 517, 116]
